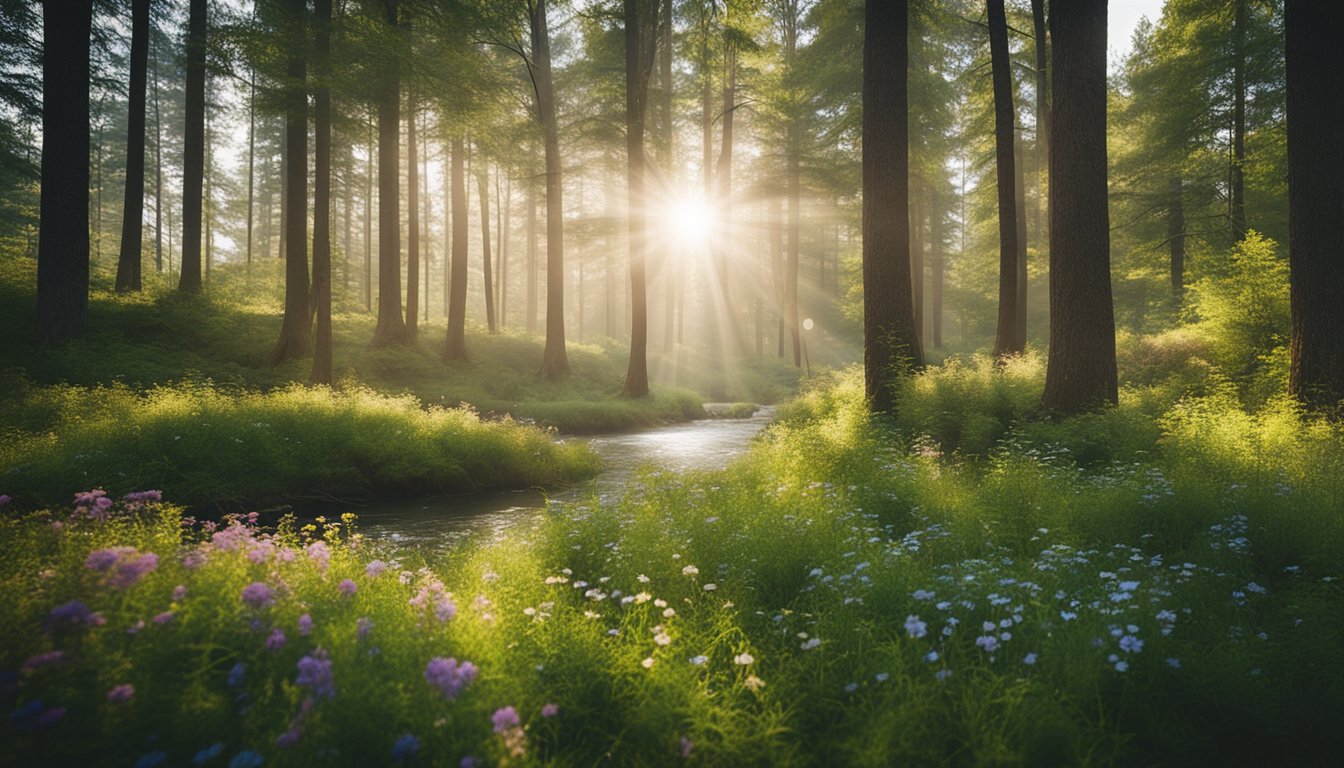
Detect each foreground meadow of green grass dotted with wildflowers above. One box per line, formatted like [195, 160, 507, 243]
[0, 364, 1344, 765]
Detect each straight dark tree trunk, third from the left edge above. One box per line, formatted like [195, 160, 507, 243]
[177, 0, 206, 293]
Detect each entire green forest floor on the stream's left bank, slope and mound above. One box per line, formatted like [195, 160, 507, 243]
[0, 260, 798, 510]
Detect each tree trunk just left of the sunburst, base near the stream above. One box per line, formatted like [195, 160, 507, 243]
[622, 0, 668, 397]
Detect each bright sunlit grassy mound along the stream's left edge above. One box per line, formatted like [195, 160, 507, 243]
[0, 382, 598, 508]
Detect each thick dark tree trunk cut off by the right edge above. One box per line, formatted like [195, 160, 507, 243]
[1284, 0, 1344, 416]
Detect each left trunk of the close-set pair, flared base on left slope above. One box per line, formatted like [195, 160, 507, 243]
[271, 0, 312, 364]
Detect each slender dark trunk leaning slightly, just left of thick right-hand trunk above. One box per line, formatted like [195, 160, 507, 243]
[986, 0, 1023, 359]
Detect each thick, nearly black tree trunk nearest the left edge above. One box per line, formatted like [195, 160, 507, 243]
[38, 0, 93, 343]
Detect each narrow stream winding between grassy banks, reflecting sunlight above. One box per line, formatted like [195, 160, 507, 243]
[351, 406, 774, 549]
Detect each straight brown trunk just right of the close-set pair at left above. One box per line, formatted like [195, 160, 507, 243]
[374, 0, 410, 346]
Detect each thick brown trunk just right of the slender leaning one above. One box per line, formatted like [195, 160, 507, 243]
[1042, 0, 1118, 413]
